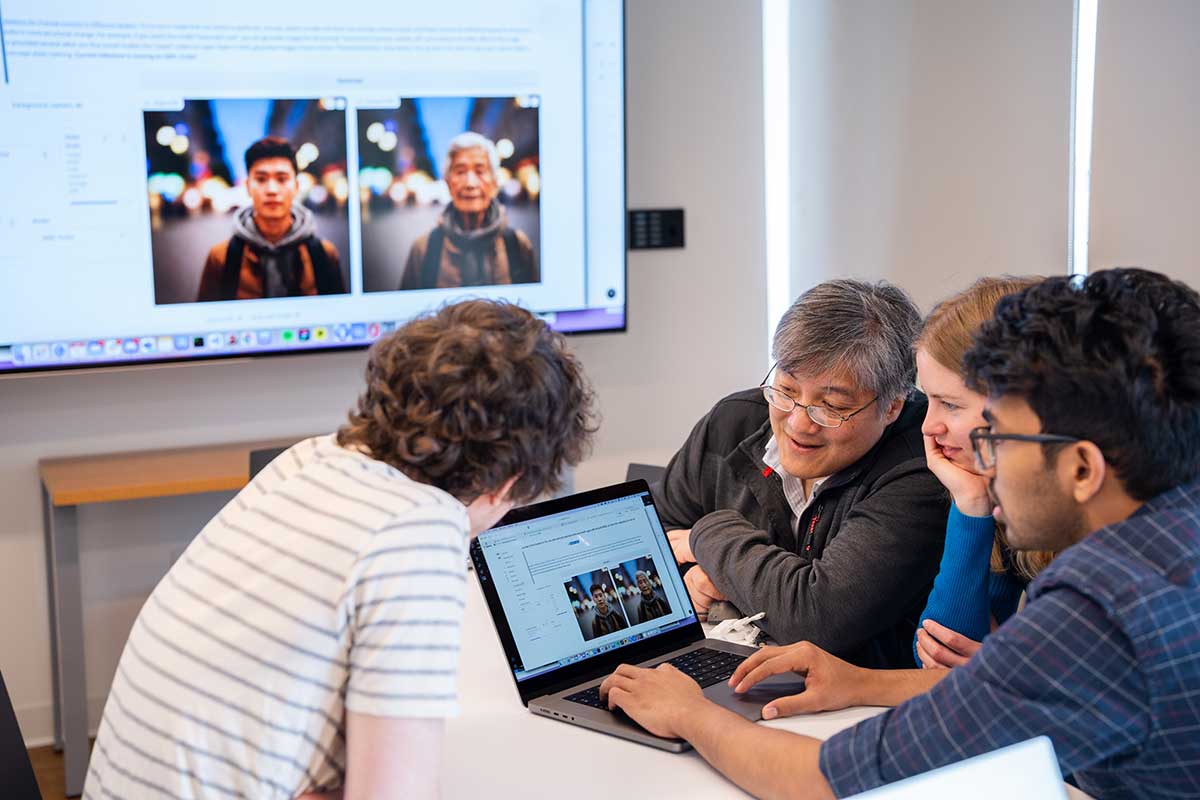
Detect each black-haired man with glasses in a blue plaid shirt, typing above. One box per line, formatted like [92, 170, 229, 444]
[601, 269, 1200, 798]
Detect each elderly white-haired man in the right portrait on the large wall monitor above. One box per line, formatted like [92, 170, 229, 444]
[400, 131, 541, 289]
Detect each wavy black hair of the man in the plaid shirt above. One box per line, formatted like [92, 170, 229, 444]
[964, 267, 1200, 500]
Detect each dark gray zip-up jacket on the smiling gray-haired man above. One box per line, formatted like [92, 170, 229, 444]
[654, 389, 949, 668]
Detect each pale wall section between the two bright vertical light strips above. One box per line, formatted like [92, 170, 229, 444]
[791, 0, 1075, 308]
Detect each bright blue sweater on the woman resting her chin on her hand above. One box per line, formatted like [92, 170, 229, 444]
[912, 505, 1027, 667]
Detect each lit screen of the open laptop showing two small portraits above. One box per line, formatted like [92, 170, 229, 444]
[478, 483, 696, 684]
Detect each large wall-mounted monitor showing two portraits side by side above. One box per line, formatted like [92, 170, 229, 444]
[0, 0, 625, 375]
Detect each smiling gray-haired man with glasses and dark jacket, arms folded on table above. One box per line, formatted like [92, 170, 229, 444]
[655, 279, 949, 667]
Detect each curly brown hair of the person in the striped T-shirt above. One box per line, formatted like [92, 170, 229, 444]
[337, 300, 596, 503]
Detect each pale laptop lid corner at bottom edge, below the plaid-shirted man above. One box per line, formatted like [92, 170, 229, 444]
[853, 736, 1067, 800]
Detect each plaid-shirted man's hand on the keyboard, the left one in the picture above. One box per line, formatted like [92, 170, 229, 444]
[600, 663, 710, 739]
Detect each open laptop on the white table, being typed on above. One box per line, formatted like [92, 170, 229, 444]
[470, 481, 804, 752]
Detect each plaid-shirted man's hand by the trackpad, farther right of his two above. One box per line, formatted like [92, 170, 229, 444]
[730, 642, 871, 720]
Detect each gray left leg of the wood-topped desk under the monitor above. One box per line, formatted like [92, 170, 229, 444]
[42, 487, 90, 798]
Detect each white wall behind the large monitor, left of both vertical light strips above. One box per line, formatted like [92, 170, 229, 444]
[0, 0, 766, 741]
